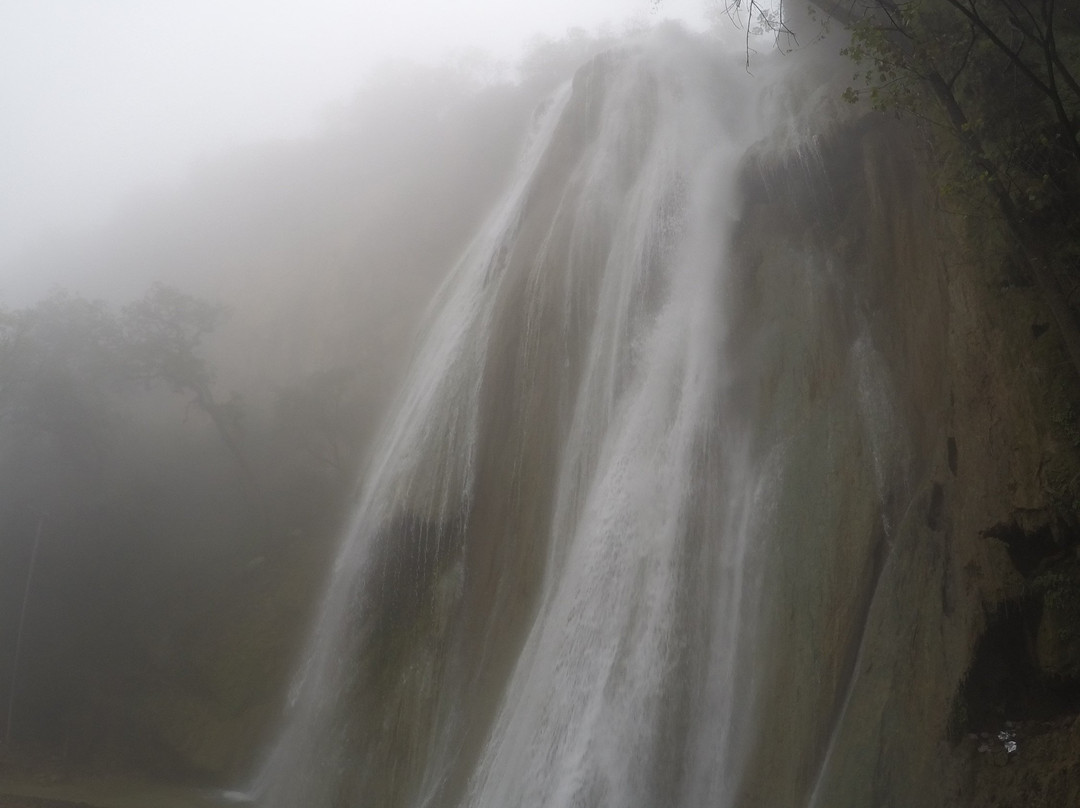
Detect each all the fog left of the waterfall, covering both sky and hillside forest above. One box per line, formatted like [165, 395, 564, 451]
[0, 0, 741, 777]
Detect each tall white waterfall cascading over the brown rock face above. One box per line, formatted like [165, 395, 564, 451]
[255, 23, 920, 808]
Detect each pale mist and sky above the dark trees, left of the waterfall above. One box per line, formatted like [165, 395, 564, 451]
[0, 0, 707, 466]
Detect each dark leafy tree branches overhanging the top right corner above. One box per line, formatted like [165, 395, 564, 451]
[818, 0, 1080, 373]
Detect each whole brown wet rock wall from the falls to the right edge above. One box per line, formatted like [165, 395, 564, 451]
[737, 90, 1080, 807]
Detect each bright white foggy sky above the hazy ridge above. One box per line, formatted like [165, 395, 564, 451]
[0, 0, 707, 301]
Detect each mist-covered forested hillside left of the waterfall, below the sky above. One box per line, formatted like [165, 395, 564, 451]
[0, 31, 630, 776]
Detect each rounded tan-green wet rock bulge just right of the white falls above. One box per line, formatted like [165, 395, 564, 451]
[737, 109, 971, 807]
